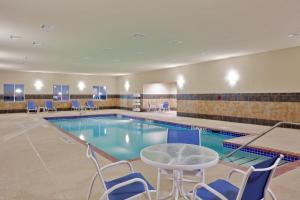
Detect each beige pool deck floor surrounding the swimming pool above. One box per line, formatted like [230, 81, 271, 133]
[0, 110, 300, 200]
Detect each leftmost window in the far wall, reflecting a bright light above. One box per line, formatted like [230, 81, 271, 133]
[4, 84, 25, 102]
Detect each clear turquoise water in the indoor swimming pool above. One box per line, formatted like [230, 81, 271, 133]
[48, 115, 288, 164]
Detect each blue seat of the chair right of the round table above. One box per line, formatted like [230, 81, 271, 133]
[196, 179, 239, 200]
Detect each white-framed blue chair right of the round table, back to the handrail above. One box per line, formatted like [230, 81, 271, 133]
[193, 155, 283, 200]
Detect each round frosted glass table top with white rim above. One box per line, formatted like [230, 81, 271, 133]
[141, 143, 219, 171]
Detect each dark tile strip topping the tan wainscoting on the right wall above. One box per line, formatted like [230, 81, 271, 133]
[177, 93, 300, 102]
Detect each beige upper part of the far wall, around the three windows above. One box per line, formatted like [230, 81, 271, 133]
[0, 71, 117, 94]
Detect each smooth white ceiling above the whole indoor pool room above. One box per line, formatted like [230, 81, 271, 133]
[0, 0, 300, 75]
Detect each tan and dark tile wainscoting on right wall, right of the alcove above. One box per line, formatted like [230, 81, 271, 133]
[177, 93, 300, 127]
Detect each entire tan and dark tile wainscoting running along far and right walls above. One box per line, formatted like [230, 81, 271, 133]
[0, 93, 300, 128]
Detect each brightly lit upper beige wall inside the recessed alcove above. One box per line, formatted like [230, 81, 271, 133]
[143, 83, 177, 94]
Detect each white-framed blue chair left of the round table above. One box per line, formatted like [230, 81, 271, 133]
[87, 144, 155, 200]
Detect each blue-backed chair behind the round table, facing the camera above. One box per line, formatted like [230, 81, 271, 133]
[157, 129, 204, 198]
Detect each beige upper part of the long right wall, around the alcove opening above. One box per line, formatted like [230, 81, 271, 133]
[118, 47, 300, 94]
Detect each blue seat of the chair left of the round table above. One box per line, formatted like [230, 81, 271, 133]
[105, 173, 154, 200]
